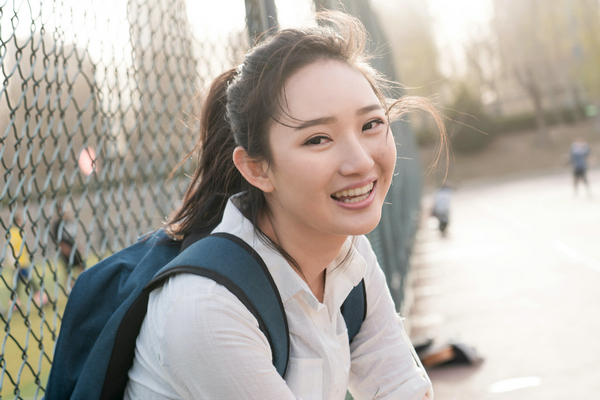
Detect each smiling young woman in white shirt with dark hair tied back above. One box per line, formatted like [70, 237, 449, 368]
[125, 10, 440, 400]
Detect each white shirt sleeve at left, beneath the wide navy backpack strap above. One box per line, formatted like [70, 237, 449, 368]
[159, 276, 295, 400]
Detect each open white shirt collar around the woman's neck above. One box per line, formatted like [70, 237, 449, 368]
[213, 196, 366, 317]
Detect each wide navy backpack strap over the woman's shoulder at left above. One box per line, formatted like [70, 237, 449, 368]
[100, 233, 289, 399]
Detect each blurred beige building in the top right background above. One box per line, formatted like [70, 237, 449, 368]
[490, 0, 600, 115]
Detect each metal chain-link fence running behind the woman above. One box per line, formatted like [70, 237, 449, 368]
[0, 0, 420, 399]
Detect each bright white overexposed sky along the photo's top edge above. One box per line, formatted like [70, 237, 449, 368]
[0, 0, 492, 75]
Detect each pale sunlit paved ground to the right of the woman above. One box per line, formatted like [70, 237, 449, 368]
[410, 170, 600, 400]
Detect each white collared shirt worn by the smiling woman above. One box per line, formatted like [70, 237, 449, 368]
[125, 200, 433, 400]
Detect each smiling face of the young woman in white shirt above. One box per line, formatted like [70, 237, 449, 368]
[265, 60, 396, 238]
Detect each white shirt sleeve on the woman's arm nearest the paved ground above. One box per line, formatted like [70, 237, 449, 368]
[349, 237, 433, 400]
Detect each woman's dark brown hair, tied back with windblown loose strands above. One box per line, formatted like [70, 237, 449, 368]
[166, 12, 444, 267]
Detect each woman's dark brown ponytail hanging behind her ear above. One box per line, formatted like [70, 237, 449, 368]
[165, 69, 244, 240]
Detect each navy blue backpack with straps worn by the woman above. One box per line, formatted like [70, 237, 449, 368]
[44, 230, 367, 400]
